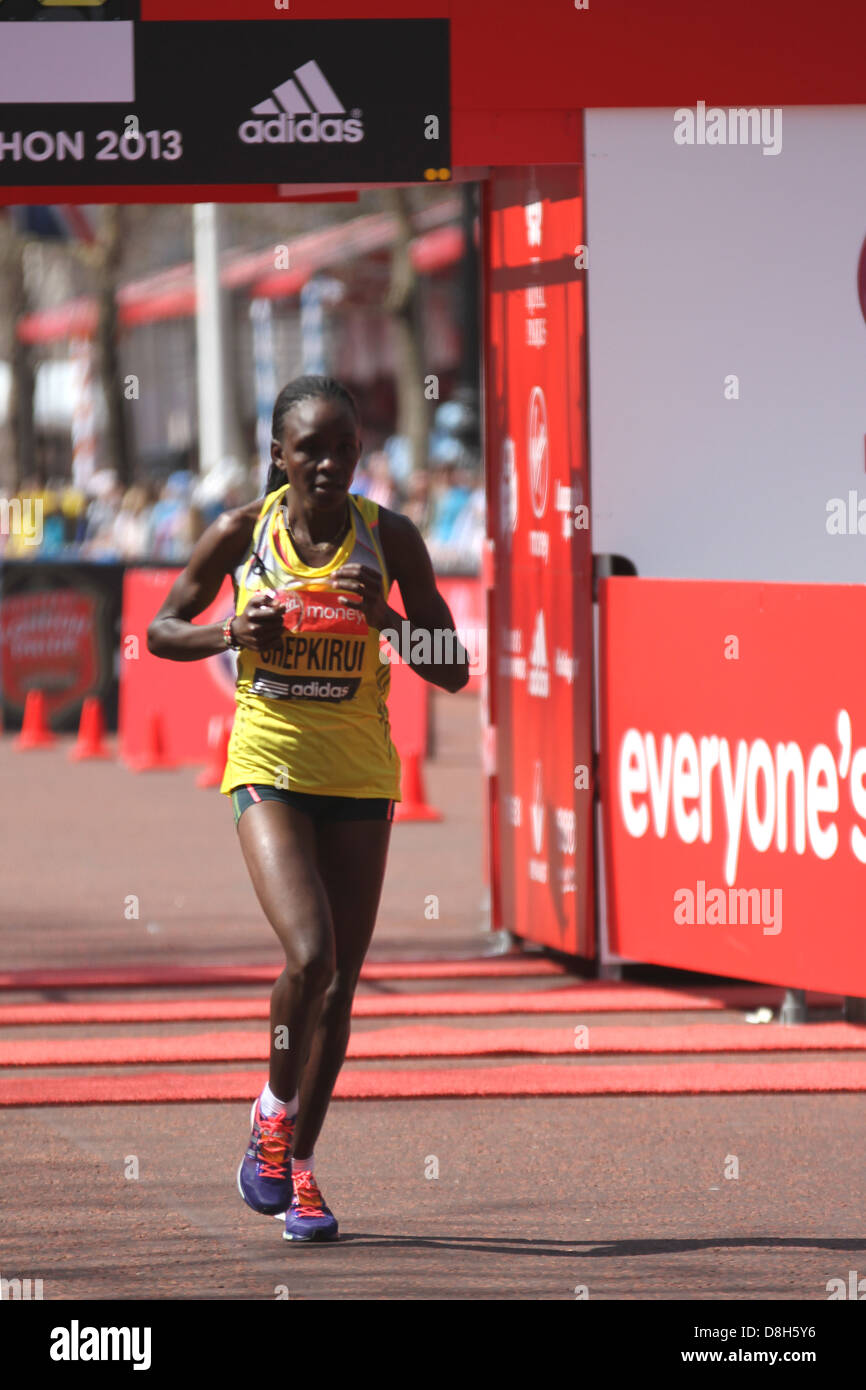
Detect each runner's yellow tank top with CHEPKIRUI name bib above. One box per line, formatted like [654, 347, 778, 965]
[220, 484, 400, 801]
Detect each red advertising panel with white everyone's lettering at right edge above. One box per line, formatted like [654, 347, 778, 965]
[599, 578, 866, 995]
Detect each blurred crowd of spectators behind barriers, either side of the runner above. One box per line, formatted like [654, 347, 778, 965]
[0, 404, 485, 574]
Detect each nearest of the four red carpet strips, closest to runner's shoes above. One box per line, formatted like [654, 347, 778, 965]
[0, 1061, 866, 1105]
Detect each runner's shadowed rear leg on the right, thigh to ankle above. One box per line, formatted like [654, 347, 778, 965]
[295, 820, 391, 1158]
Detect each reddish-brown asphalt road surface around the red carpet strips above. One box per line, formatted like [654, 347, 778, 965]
[0, 696, 866, 1302]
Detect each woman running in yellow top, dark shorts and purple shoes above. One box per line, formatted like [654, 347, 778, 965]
[147, 377, 468, 1240]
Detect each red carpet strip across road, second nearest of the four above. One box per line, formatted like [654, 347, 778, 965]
[0, 1023, 866, 1068]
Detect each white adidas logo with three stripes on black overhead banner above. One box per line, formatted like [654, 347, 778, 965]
[238, 60, 364, 145]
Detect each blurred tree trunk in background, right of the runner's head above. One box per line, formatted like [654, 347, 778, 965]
[382, 188, 428, 473]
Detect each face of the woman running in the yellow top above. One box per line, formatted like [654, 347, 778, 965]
[274, 396, 361, 512]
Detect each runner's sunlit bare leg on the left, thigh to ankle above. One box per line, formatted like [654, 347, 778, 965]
[238, 801, 336, 1101]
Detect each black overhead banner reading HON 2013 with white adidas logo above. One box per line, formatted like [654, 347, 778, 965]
[0, 19, 450, 186]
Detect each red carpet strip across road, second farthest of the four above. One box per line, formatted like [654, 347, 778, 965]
[0, 981, 842, 1027]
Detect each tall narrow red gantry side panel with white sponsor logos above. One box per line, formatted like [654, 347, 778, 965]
[487, 165, 594, 956]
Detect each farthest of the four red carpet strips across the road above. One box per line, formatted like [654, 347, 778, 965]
[0, 955, 566, 990]
